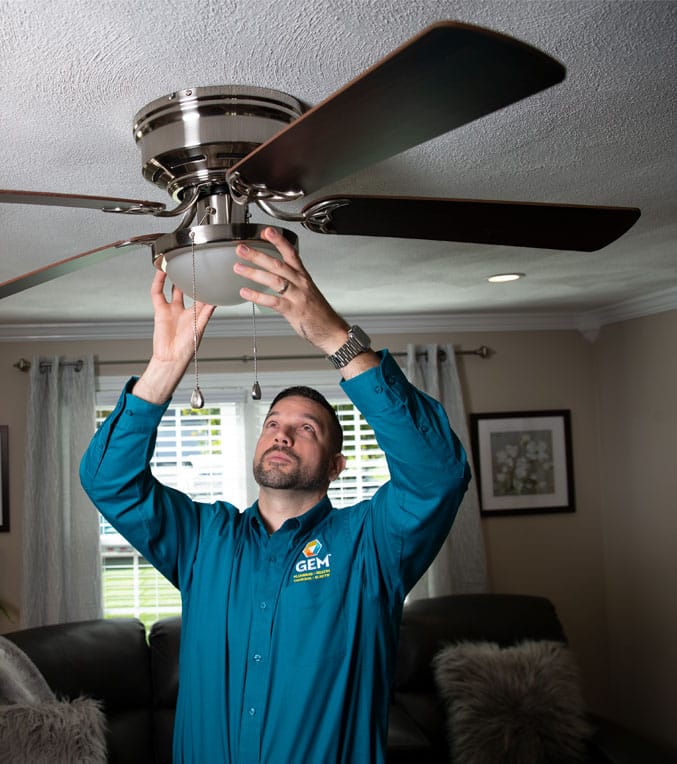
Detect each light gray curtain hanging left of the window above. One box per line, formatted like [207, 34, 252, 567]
[21, 356, 102, 628]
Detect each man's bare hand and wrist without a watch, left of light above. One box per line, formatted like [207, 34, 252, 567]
[132, 271, 214, 403]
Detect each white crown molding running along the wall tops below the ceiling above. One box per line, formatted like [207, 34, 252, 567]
[0, 287, 677, 342]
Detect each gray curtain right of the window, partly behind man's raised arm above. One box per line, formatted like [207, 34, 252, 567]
[406, 344, 488, 600]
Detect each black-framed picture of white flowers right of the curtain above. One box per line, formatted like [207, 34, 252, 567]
[470, 410, 575, 515]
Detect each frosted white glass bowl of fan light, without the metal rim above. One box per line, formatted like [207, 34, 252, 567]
[165, 239, 282, 305]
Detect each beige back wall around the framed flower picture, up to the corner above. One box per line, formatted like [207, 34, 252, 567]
[456, 332, 608, 711]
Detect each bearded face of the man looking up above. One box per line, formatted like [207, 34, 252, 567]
[254, 396, 345, 491]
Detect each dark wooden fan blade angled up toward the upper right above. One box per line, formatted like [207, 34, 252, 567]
[229, 21, 566, 194]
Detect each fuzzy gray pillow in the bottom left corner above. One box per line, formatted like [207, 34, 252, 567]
[0, 698, 106, 764]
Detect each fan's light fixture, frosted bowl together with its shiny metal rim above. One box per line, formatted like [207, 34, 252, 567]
[152, 223, 297, 305]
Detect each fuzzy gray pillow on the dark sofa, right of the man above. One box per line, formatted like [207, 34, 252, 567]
[433, 641, 590, 764]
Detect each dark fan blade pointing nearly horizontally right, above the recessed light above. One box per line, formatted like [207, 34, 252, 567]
[303, 196, 641, 252]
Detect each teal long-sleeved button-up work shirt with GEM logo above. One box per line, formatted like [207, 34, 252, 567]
[80, 351, 469, 764]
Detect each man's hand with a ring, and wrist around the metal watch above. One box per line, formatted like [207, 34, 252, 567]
[233, 227, 378, 377]
